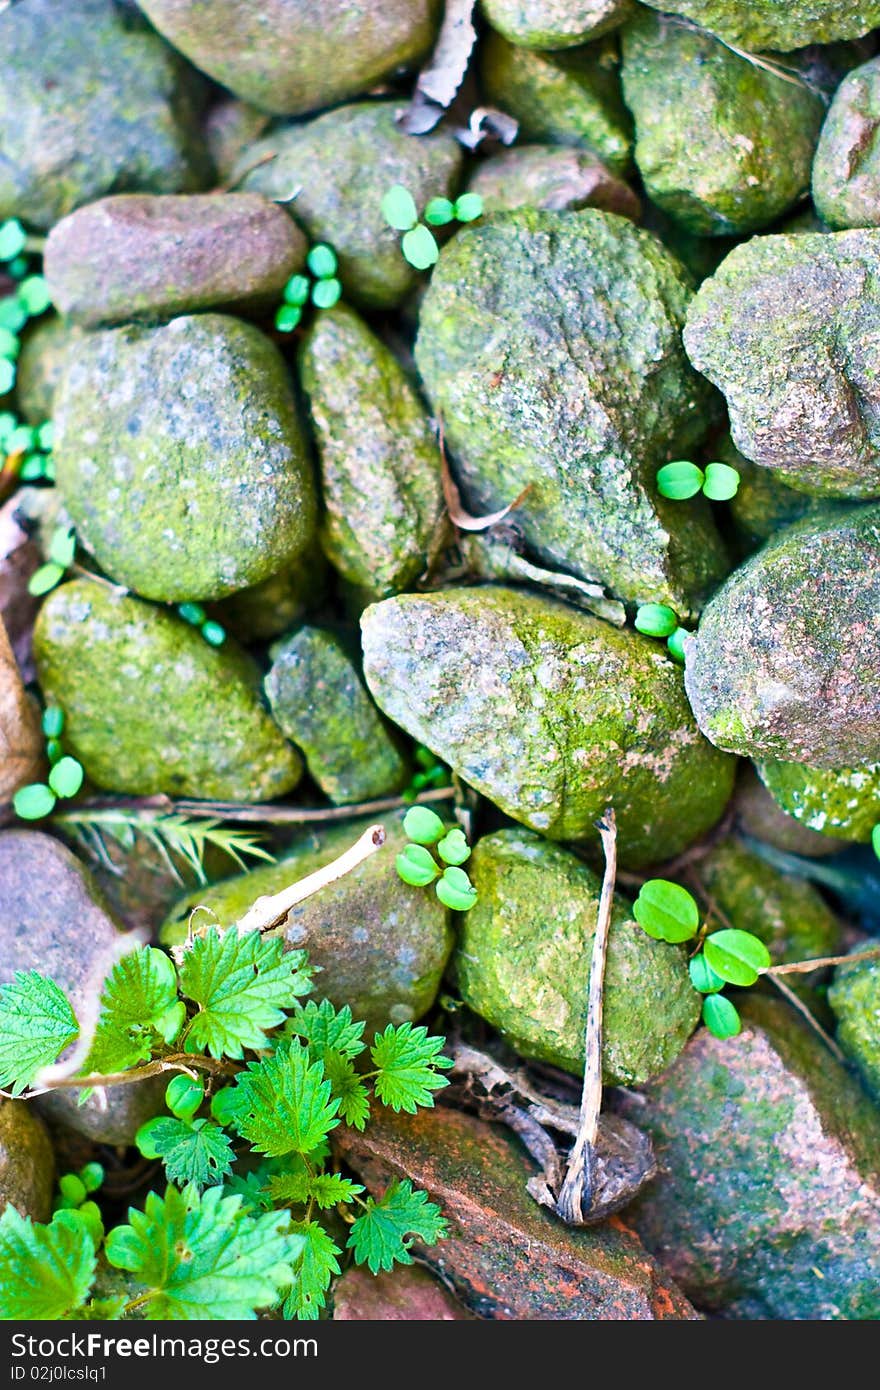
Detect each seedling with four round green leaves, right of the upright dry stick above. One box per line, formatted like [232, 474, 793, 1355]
[633, 878, 770, 1038]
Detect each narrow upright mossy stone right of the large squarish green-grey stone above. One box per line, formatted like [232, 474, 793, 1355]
[299, 304, 445, 599]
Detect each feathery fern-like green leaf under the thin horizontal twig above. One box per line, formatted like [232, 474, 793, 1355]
[53, 808, 275, 884]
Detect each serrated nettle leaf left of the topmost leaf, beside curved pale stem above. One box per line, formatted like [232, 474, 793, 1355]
[85, 947, 185, 1074]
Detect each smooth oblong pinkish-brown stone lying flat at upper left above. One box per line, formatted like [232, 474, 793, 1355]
[43, 193, 307, 328]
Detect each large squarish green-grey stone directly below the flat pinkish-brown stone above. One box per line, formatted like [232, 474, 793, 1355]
[54, 314, 317, 602]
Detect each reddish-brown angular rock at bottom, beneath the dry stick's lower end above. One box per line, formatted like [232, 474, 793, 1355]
[336, 1108, 696, 1322]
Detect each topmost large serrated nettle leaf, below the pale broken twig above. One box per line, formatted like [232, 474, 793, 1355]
[181, 927, 311, 1058]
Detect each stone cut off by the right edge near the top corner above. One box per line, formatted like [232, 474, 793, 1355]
[813, 58, 880, 227]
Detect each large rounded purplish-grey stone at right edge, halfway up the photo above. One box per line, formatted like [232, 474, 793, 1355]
[685, 506, 880, 767]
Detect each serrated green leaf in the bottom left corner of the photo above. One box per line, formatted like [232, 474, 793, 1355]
[0, 1207, 96, 1322]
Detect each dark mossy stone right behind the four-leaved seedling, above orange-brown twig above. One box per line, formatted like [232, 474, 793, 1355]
[695, 835, 840, 994]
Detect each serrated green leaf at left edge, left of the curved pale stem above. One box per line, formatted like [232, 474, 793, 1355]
[0, 970, 79, 1095]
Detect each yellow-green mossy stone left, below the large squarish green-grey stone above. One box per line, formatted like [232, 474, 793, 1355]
[33, 580, 302, 801]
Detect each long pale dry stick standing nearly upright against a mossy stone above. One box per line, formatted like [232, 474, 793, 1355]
[556, 806, 617, 1226]
